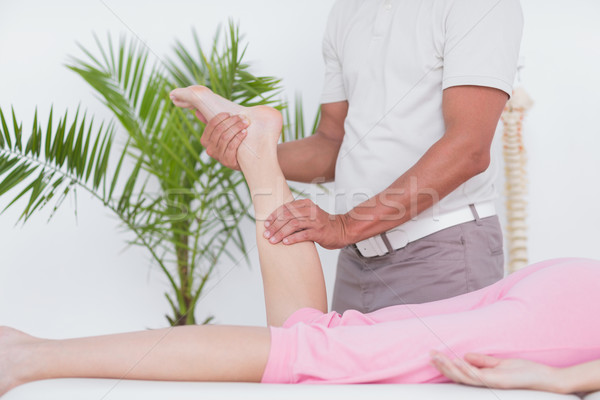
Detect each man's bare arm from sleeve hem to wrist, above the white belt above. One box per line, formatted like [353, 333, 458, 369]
[338, 86, 508, 243]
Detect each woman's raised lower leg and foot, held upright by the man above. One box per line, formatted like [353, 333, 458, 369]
[171, 86, 327, 326]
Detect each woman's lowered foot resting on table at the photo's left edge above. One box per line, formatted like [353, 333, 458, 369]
[0, 326, 40, 396]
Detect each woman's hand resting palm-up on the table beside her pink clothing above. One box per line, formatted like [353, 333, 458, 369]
[431, 351, 562, 392]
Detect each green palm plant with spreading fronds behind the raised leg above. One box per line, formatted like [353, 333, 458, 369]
[0, 23, 318, 325]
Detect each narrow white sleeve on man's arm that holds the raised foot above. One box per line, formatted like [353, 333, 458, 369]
[321, 2, 347, 103]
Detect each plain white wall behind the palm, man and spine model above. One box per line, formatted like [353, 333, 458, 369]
[0, 0, 600, 337]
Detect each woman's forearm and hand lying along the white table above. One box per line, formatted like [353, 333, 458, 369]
[431, 352, 600, 393]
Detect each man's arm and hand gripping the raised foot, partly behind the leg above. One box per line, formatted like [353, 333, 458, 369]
[201, 101, 348, 182]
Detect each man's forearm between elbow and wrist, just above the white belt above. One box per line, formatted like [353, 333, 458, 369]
[344, 133, 489, 243]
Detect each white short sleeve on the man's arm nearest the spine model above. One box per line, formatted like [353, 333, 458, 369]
[442, 0, 523, 96]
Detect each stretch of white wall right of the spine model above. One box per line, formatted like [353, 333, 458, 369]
[522, 0, 600, 261]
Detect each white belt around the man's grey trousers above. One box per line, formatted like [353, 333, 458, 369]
[355, 201, 496, 257]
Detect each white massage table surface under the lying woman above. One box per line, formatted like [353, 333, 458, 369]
[2, 379, 600, 400]
